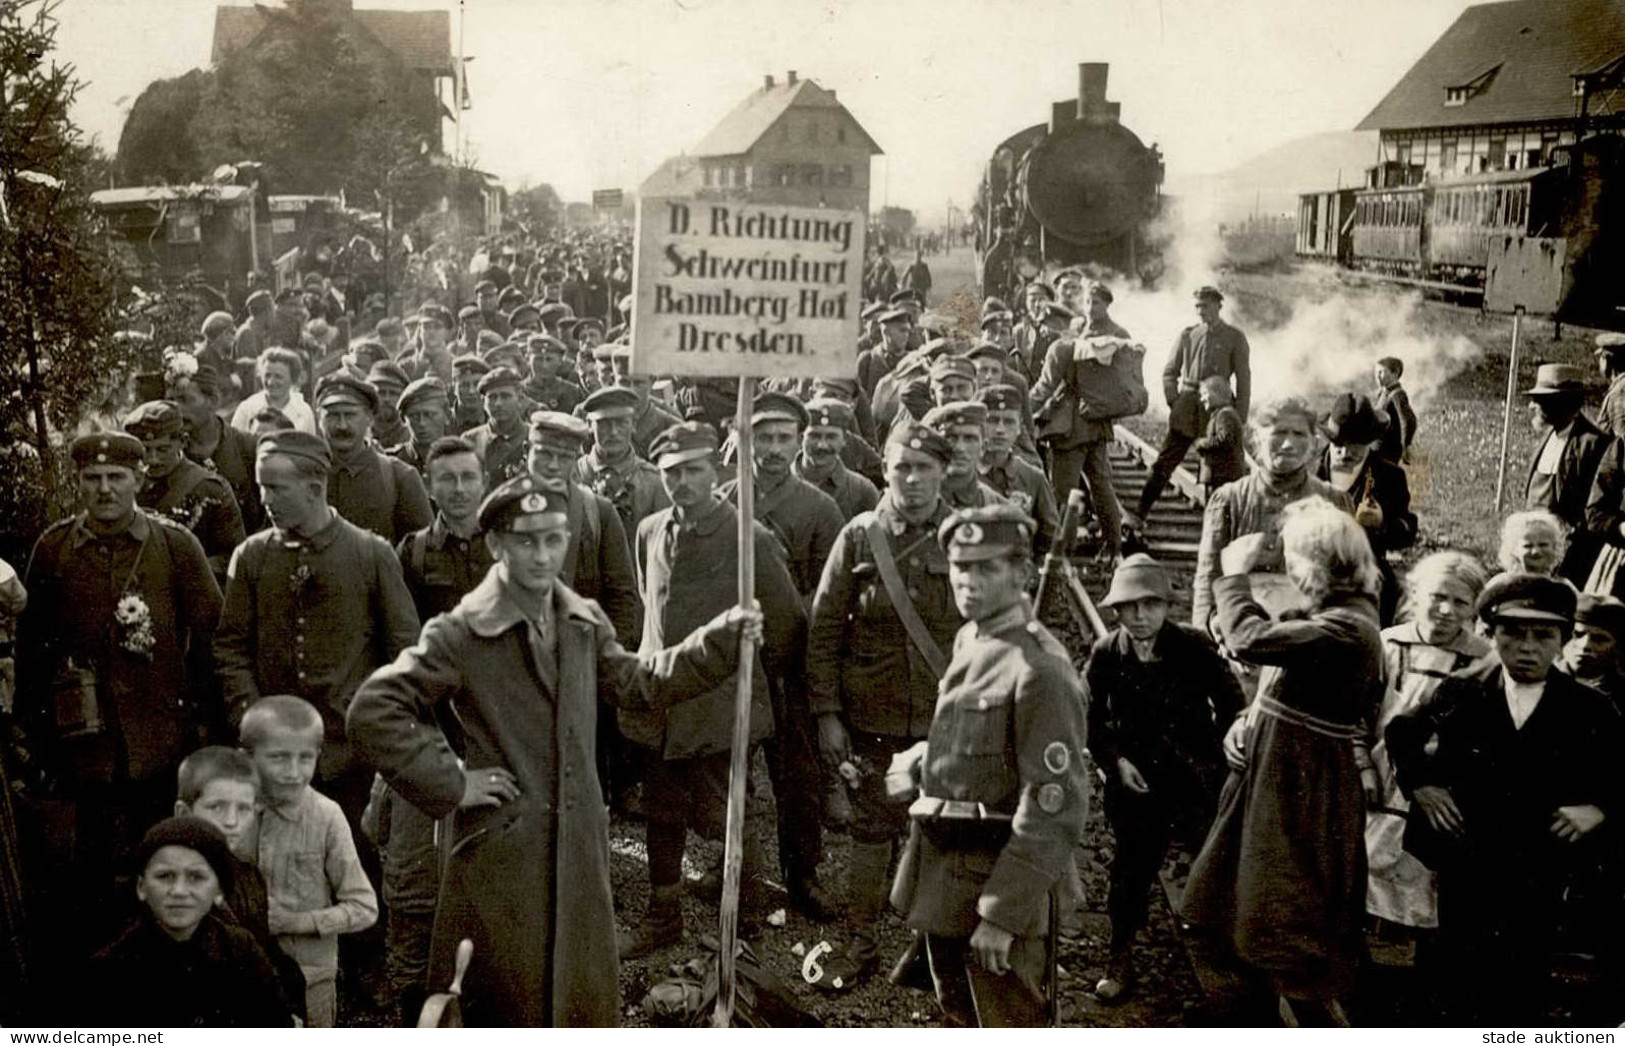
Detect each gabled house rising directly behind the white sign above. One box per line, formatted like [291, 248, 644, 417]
[639, 71, 881, 213]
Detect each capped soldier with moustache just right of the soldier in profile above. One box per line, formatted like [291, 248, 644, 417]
[315, 370, 434, 542]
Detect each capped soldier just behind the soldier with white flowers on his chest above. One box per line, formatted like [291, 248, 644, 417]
[124, 400, 247, 581]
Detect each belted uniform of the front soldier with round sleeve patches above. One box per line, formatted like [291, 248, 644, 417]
[892, 601, 1089, 1025]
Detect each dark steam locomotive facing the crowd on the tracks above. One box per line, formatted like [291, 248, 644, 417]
[972, 62, 1164, 304]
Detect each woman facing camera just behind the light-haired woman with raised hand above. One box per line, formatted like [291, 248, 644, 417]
[1191, 396, 1354, 632]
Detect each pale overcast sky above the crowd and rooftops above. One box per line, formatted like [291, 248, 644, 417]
[59, 0, 1467, 221]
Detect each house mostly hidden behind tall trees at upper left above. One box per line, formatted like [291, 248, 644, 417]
[210, 0, 466, 153]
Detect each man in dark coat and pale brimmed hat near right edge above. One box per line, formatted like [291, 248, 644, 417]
[1524, 364, 1612, 585]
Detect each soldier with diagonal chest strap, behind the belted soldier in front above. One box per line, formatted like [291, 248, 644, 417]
[808, 424, 960, 991]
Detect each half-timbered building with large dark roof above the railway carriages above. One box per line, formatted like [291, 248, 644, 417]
[1355, 0, 1625, 184]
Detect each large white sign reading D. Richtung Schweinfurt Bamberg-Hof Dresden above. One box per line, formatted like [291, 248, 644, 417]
[632, 197, 865, 377]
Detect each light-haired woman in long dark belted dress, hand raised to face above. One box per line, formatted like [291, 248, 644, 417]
[1181, 493, 1383, 1027]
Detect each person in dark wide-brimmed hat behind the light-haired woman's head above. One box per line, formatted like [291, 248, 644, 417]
[1318, 393, 1417, 629]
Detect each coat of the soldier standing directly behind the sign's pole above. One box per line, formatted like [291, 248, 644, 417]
[618, 500, 806, 759]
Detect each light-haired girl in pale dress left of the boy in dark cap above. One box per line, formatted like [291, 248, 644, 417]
[1362, 552, 1488, 939]
